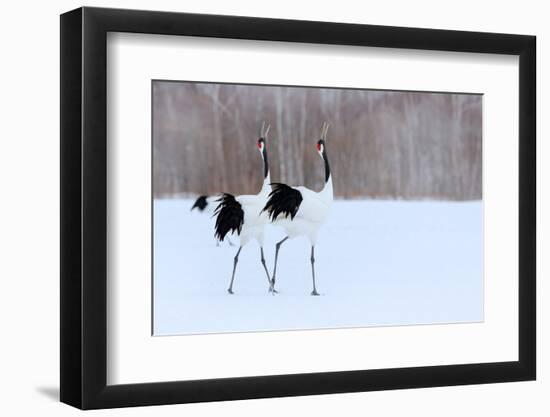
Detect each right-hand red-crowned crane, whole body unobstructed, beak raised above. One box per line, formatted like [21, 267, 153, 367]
[262, 123, 334, 295]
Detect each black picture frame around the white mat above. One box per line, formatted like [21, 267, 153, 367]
[60, 7, 536, 409]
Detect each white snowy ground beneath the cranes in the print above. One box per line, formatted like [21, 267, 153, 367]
[153, 199, 483, 335]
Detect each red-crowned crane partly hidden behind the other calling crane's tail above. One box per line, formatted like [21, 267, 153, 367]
[214, 123, 273, 294]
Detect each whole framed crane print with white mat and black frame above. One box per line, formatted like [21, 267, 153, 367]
[61, 7, 536, 409]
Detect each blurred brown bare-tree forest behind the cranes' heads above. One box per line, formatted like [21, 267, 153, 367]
[152, 81, 482, 200]
